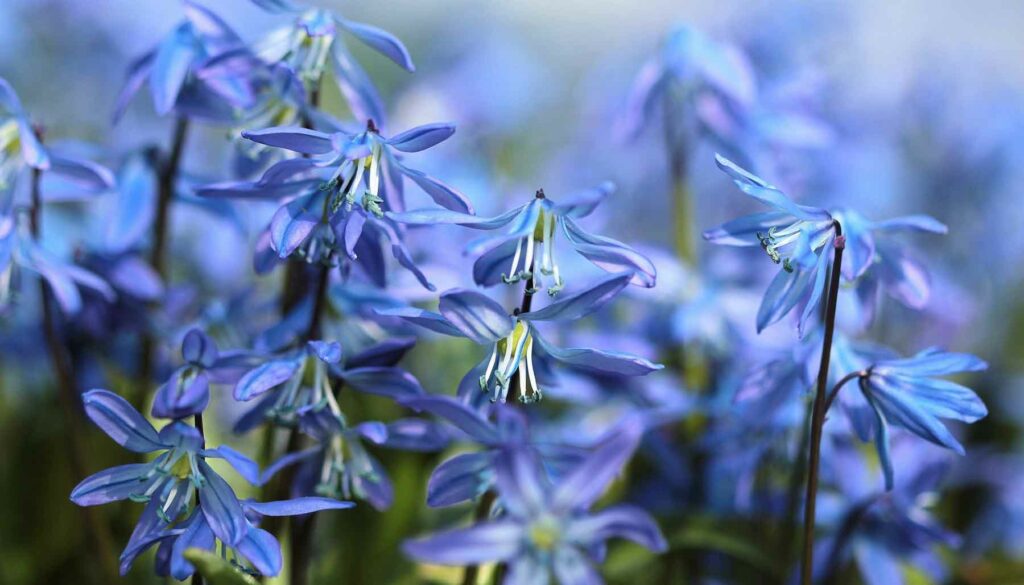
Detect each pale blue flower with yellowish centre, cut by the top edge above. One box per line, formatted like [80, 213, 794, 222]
[249, 1, 416, 125]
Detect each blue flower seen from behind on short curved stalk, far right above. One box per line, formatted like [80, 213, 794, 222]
[860, 348, 988, 489]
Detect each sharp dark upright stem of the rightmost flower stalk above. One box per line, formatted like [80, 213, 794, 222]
[801, 221, 846, 585]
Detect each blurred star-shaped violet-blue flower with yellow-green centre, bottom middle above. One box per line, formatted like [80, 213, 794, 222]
[403, 426, 668, 584]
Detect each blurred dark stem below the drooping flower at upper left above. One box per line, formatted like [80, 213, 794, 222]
[134, 116, 188, 395]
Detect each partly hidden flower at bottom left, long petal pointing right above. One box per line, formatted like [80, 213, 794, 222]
[157, 498, 355, 581]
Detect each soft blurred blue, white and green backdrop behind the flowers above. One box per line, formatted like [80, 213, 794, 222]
[0, 0, 1024, 584]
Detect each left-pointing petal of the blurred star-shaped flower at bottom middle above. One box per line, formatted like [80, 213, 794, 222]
[401, 520, 524, 566]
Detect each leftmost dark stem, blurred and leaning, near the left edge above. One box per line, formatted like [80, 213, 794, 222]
[29, 146, 120, 583]
